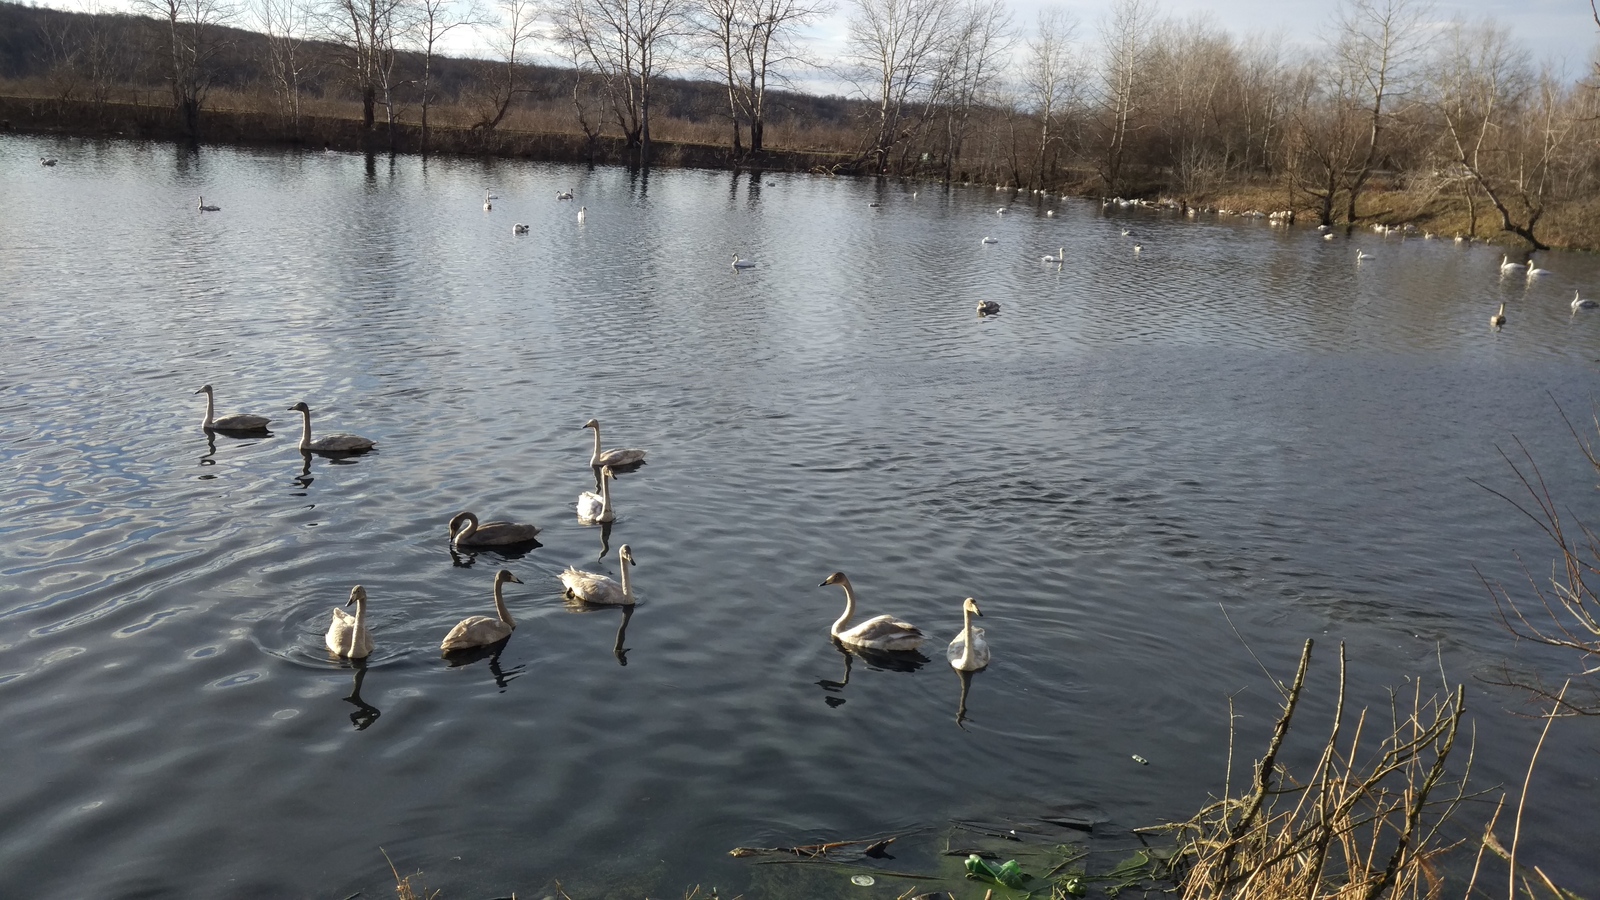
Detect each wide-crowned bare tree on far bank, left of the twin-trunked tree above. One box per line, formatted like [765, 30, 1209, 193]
[554, 0, 690, 165]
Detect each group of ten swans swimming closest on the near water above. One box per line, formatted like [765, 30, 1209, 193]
[195, 384, 989, 673]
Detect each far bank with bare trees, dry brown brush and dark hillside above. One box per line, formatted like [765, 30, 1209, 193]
[9, 0, 1600, 251]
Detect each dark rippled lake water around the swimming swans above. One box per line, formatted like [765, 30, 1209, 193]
[0, 136, 1600, 898]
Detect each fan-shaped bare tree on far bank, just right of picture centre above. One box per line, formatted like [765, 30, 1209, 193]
[848, 0, 958, 173]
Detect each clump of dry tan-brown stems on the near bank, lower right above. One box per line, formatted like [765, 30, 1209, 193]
[1163, 641, 1470, 900]
